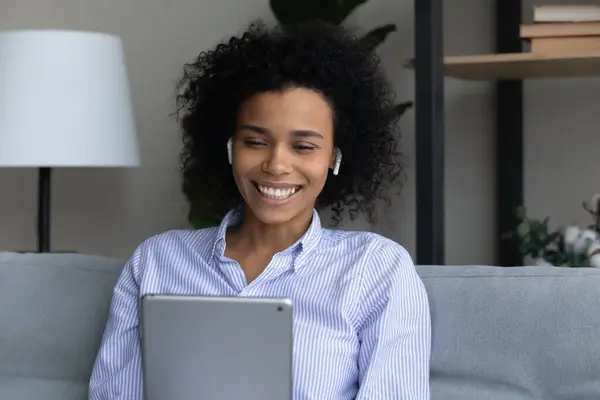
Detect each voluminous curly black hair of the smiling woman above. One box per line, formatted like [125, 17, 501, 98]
[177, 22, 404, 224]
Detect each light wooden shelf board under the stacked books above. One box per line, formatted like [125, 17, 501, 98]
[406, 51, 600, 81]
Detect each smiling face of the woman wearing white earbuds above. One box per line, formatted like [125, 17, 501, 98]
[232, 88, 333, 224]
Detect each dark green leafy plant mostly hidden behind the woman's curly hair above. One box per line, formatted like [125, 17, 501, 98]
[188, 0, 413, 229]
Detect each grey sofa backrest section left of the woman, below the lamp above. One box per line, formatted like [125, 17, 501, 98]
[0, 253, 124, 383]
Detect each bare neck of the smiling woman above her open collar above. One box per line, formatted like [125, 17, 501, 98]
[227, 205, 313, 255]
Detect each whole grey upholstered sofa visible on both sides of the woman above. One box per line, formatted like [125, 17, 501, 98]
[0, 253, 600, 400]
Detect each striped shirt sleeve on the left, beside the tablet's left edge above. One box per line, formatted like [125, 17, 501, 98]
[89, 248, 142, 400]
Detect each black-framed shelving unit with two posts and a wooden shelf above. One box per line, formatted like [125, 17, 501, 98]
[410, 0, 524, 266]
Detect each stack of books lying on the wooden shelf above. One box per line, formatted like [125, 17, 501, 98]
[520, 4, 600, 54]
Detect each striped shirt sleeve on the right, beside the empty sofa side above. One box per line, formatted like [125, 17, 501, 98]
[356, 241, 431, 400]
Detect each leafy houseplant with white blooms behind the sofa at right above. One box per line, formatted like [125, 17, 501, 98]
[506, 194, 600, 268]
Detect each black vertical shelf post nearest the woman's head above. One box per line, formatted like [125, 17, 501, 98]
[414, 0, 446, 265]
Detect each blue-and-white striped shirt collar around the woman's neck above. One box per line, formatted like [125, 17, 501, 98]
[213, 207, 323, 262]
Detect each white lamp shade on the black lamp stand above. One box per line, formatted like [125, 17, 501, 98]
[0, 30, 139, 167]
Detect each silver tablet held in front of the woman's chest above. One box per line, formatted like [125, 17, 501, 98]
[141, 295, 293, 400]
